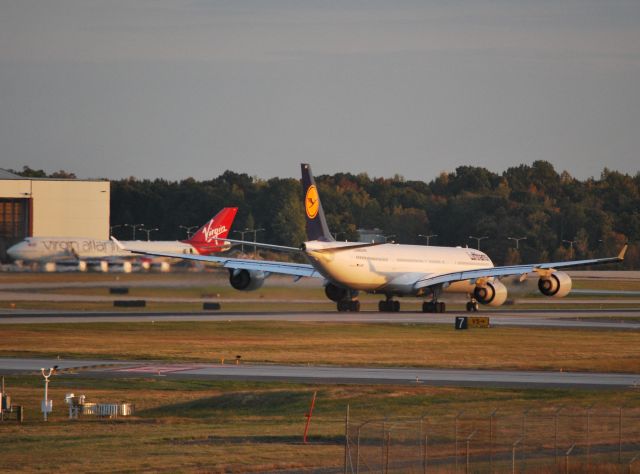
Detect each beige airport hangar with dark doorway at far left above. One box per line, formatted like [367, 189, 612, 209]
[0, 169, 111, 261]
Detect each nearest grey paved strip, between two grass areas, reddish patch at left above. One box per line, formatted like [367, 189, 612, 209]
[0, 358, 640, 389]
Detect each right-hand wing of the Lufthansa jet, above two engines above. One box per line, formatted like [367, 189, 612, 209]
[413, 245, 627, 290]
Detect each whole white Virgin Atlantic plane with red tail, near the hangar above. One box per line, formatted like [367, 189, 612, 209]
[7, 207, 238, 270]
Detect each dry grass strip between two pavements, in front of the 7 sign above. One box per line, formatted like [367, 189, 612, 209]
[0, 321, 640, 373]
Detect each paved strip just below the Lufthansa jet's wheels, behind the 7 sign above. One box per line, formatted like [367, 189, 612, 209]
[0, 309, 640, 331]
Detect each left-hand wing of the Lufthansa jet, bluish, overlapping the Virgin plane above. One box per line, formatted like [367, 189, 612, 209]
[112, 237, 323, 278]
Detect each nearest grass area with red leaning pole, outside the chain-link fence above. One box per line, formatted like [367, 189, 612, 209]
[0, 375, 640, 472]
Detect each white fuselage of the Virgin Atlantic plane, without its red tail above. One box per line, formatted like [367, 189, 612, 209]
[7, 237, 208, 262]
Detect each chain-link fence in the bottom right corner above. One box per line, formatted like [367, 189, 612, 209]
[344, 407, 640, 473]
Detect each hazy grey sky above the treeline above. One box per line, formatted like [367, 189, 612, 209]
[0, 0, 640, 181]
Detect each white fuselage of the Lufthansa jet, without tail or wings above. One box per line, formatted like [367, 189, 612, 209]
[305, 241, 493, 296]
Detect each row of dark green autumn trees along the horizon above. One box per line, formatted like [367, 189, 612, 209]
[10, 161, 640, 268]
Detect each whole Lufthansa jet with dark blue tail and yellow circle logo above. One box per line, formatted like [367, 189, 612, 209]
[117, 163, 627, 313]
